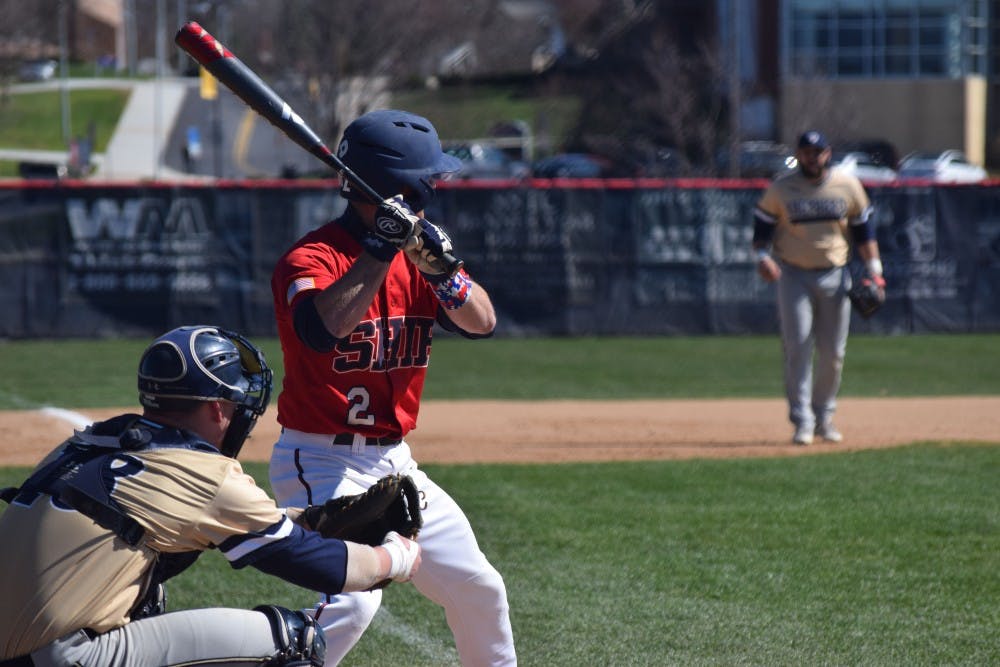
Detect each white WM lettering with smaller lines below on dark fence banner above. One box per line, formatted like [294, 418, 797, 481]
[66, 197, 215, 294]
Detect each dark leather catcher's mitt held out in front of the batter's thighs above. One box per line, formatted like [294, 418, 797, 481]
[302, 475, 424, 546]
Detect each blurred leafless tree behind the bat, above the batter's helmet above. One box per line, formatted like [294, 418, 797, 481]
[223, 0, 497, 142]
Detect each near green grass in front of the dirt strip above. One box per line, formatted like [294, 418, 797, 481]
[0, 444, 1000, 667]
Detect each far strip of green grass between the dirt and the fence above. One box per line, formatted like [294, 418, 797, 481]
[0, 334, 1000, 408]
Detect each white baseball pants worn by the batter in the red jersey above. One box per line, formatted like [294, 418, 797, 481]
[270, 429, 517, 667]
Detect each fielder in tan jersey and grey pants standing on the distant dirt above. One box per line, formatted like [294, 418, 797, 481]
[753, 131, 885, 445]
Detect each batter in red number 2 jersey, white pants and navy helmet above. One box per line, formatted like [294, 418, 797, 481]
[270, 110, 516, 666]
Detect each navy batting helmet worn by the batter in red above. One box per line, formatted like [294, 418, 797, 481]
[337, 109, 462, 211]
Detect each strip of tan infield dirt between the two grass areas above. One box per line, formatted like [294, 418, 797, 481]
[0, 396, 1000, 465]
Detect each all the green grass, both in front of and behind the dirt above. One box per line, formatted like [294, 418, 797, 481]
[0, 335, 1000, 667]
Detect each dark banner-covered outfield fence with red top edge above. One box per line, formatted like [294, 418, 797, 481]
[0, 179, 1000, 338]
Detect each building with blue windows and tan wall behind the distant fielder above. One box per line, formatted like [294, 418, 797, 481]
[778, 0, 1000, 164]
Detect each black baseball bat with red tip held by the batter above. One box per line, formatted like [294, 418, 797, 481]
[174, 21, 464, 275]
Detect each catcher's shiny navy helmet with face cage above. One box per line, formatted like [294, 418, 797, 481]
[139, 326, 272, 458]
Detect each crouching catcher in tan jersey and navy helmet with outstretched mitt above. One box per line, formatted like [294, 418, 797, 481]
[0, 326, 420, 667]
